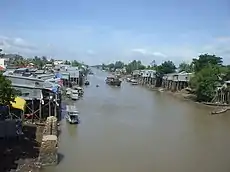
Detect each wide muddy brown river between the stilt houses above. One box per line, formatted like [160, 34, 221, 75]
[44, 71, 230, 172]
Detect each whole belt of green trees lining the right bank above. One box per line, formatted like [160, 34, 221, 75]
[100, 54, 230, 102]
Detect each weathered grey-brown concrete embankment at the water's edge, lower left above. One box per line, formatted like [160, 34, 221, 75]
[16, 116, 58, 172]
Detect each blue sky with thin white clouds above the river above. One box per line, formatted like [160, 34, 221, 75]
[0, 0, 230, 65]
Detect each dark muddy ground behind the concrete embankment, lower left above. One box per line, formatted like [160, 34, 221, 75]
[0, 125, 43, 172]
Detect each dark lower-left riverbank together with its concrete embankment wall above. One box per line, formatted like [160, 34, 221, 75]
[0, 116, 58, 172]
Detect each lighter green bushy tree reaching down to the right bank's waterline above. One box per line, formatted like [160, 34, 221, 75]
[190, 64, 221, 102]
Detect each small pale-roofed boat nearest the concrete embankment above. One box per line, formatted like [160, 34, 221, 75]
[65, 105, 80, 124]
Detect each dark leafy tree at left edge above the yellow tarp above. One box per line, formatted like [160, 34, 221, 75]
[0, 74, 18, 106]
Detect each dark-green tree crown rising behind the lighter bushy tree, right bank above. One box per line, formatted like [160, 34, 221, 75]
[192, 54, 223, 72]
